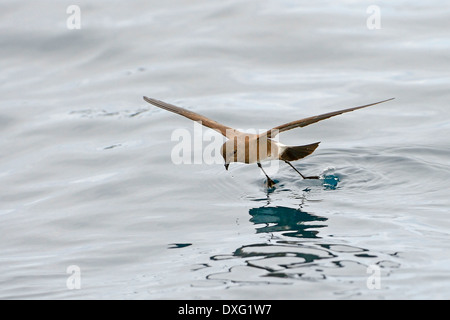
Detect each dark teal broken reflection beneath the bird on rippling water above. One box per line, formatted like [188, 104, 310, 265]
[206, 206, 400, 290]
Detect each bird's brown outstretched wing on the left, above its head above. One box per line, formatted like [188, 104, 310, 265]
[144, 97, 239, 138]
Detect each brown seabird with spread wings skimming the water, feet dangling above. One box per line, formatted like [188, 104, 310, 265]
[144, 96, 394, 188]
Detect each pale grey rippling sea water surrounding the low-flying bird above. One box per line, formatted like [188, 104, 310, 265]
[0, 0, 450, 299]
